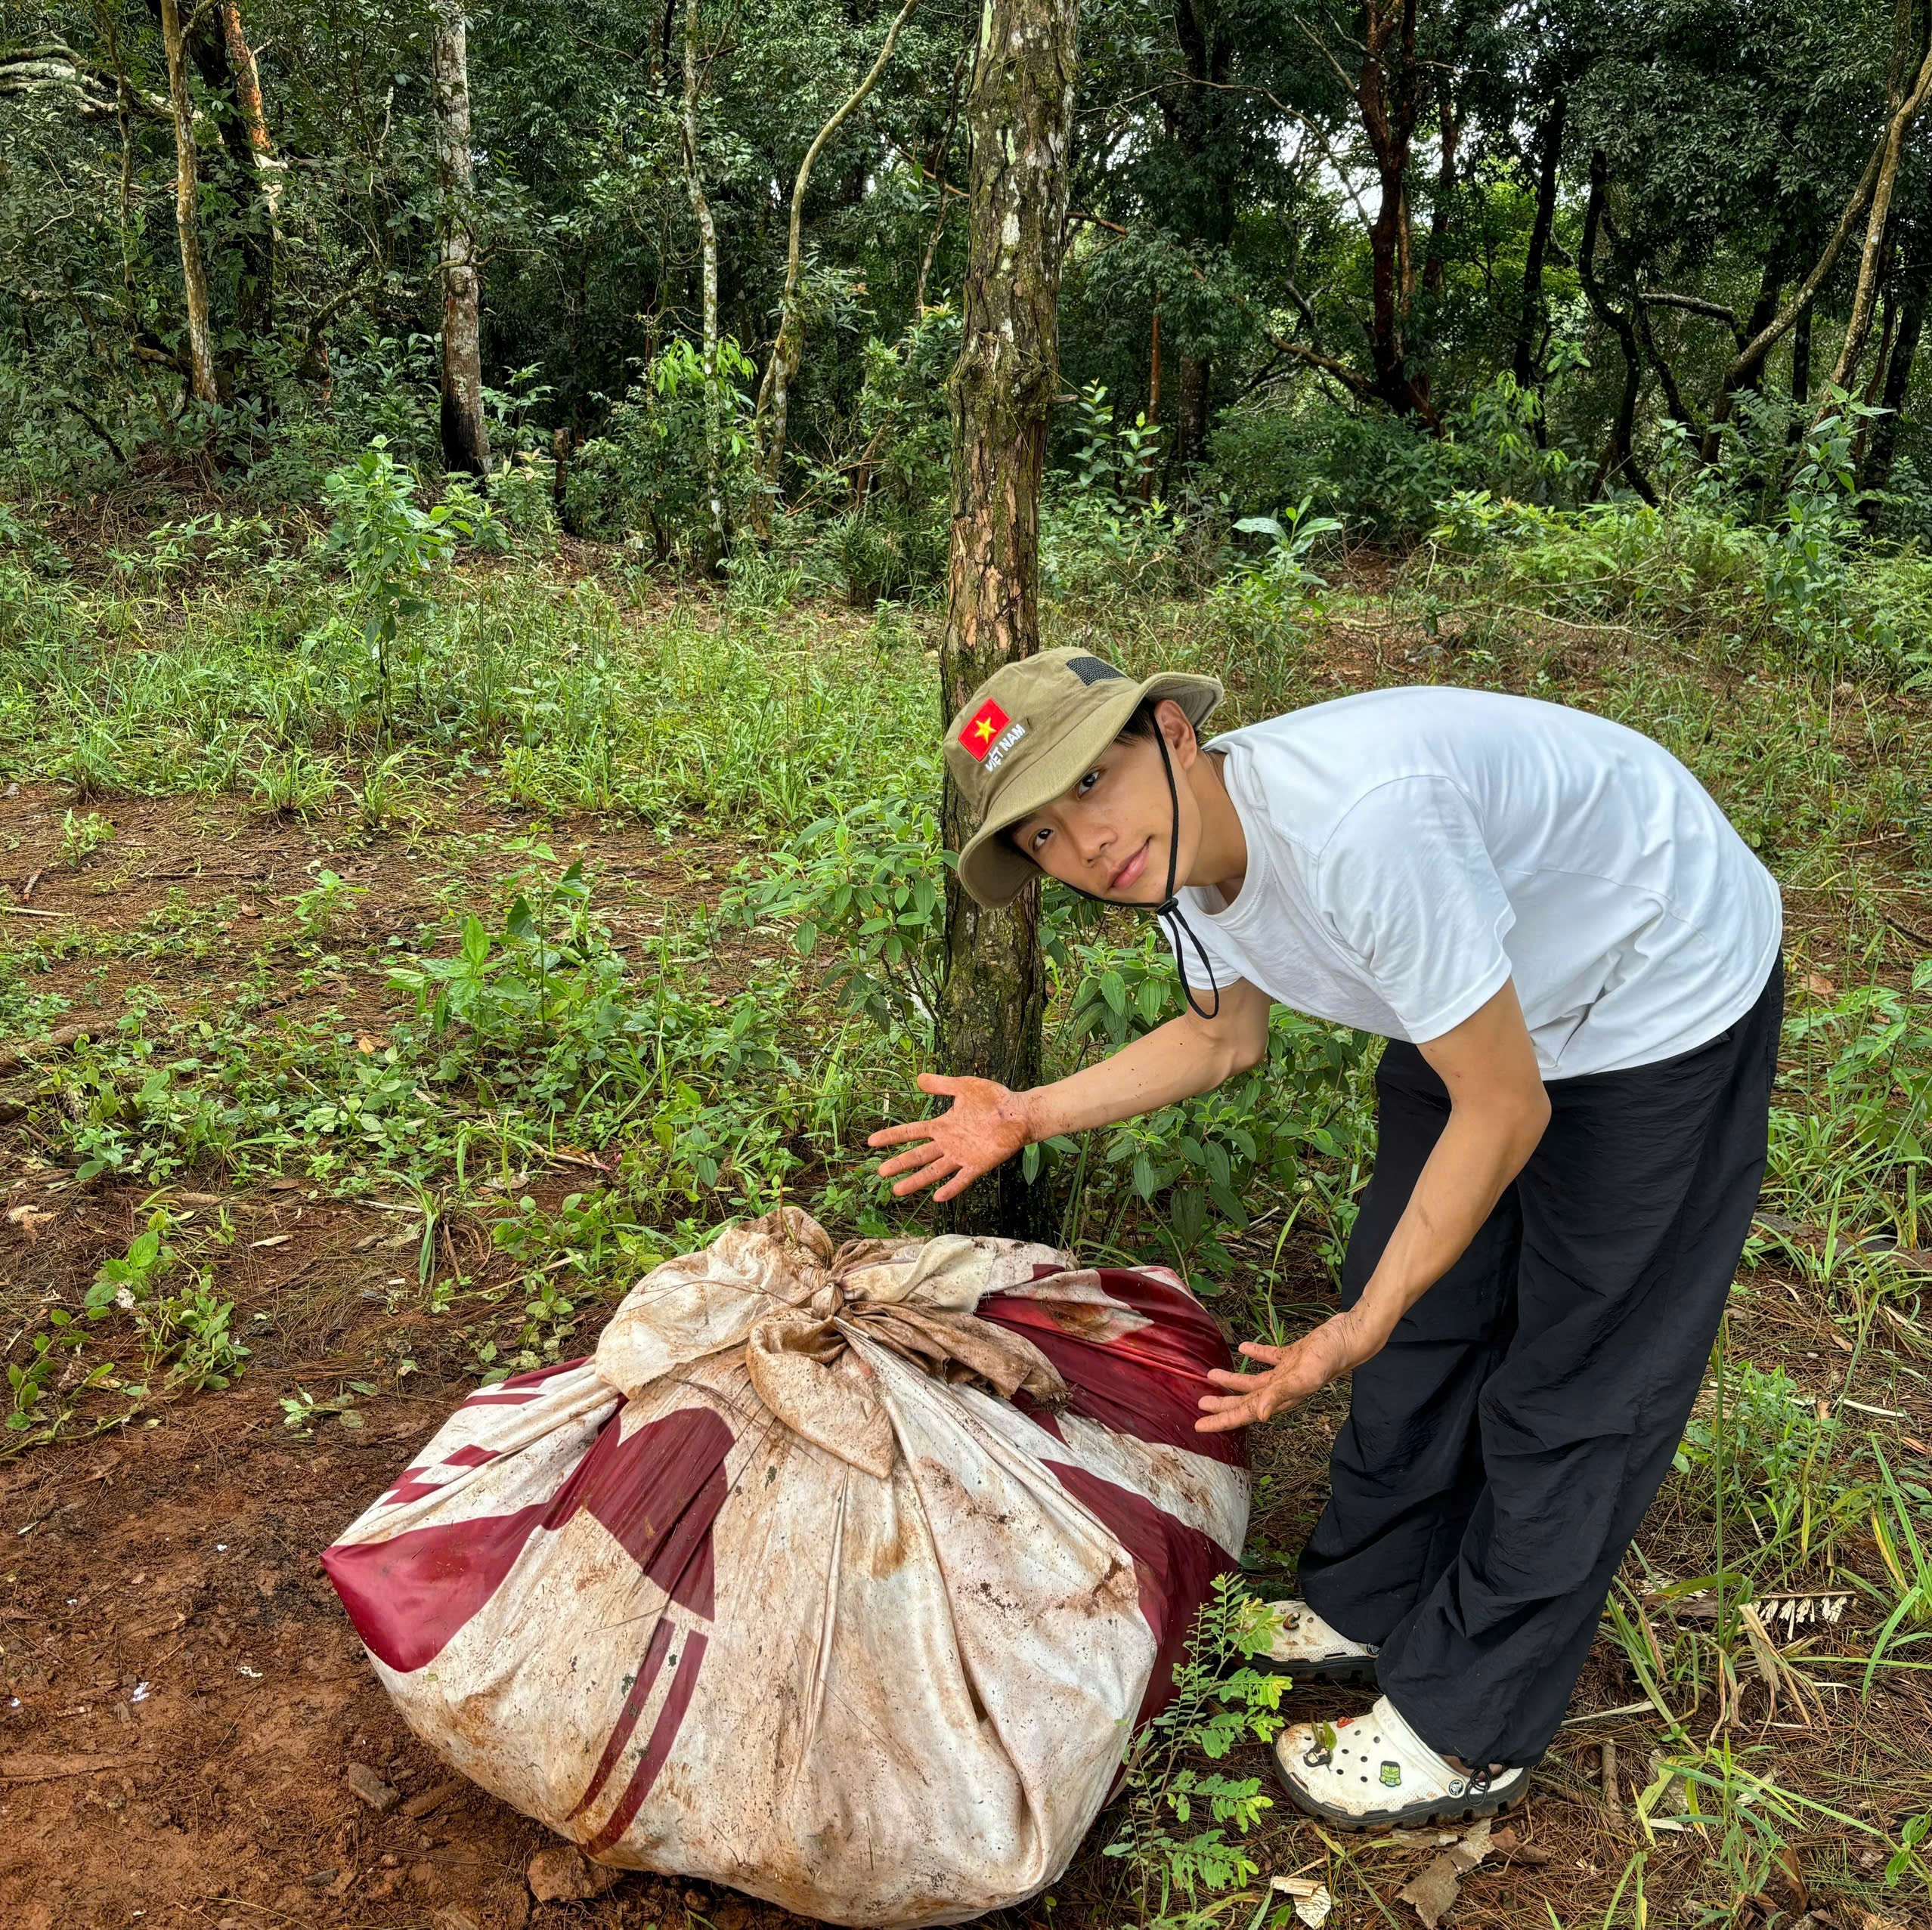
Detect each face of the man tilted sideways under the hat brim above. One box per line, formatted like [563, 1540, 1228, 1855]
[1012, 704, 1200, 904]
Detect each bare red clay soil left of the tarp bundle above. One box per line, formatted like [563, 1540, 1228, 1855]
[0, 1387, 745, 1930]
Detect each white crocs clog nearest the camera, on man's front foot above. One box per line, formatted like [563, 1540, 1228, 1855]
[1275, 1696, 1530, 1829]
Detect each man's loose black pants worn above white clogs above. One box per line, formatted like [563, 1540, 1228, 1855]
[1300, 966, 1783, 1764]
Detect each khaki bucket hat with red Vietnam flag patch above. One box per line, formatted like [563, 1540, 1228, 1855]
[946, 649, 1223, 910]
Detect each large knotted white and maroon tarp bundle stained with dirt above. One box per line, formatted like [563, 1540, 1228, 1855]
[323, 1208, 1248, 1924]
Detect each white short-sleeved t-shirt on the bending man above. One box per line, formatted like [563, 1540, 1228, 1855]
[1181, 686, 1783, 1080]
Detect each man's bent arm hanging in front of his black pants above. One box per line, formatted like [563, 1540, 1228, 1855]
[1194, 979, 1550, 1434]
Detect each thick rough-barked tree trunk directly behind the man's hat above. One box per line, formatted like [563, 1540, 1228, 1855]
[939, 0, 1078, 1233]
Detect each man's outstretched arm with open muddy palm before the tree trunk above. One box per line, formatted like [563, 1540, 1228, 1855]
[865, 979, 1269, 1200]
